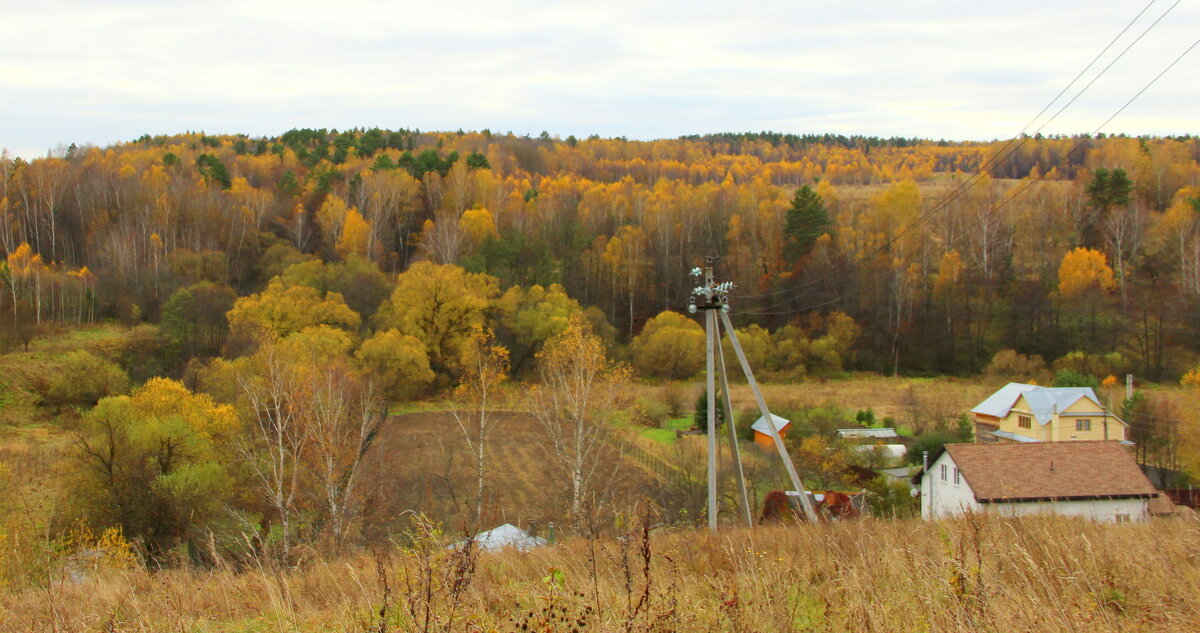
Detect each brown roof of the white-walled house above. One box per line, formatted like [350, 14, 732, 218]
[946, 440, 1157, 504]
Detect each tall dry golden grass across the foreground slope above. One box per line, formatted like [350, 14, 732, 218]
[0, 516, 1200, 633]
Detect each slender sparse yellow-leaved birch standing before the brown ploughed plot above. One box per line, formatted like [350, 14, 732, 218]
[450, 326, 509, 526]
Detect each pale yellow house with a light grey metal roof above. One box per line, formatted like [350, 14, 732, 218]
[971, 382, 1132, 445]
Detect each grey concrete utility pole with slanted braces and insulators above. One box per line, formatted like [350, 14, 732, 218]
[688, 257, 817, 531]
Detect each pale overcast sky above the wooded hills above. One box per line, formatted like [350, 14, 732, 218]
[0, 0, 1200, 158]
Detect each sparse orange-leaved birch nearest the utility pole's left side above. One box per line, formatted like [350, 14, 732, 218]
[528, 317, 629, 526]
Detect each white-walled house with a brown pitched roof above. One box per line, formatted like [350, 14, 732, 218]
[914, 440, 1158, 523]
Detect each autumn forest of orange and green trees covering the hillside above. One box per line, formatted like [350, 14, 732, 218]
[0, 129, 1200, 376]
